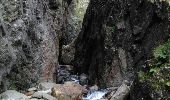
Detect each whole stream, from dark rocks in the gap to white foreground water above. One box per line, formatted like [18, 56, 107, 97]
[58, 65, 108, 100]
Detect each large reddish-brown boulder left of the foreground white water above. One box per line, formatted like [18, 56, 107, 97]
[52, 82, 85, 100]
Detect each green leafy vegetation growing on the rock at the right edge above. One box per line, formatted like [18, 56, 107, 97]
[138, 39, 170, 91]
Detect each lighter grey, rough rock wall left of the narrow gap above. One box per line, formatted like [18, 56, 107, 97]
[0, 0, 89, 92]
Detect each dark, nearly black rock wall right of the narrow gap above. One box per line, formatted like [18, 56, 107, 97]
[75, 0, 170, 100]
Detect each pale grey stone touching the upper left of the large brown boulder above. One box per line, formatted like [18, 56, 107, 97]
[38, 82, 55, 91]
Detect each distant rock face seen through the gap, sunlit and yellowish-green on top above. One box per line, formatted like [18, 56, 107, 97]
[59, 0, 89, 64]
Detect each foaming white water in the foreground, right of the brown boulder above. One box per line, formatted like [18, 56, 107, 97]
[83, 90, 108, 100]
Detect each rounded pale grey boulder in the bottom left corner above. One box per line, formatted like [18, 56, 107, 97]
[0, 90, 29, 100]
